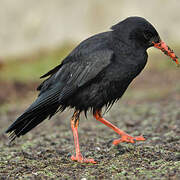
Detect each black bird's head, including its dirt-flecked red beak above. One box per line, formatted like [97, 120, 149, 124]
[111, 16, 180, 66]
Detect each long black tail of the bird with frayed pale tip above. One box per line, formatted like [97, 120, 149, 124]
[5, 91, 60, 142]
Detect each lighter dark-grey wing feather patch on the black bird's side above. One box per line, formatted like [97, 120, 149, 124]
[59, 50, 113, 100]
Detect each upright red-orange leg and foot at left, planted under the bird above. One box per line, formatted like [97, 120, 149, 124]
[71, 111, 96, 164]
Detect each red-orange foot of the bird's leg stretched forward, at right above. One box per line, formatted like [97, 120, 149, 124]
[113, 134, 146, 145]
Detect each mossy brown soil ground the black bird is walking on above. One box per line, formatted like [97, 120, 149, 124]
[0, 67, 180, 180]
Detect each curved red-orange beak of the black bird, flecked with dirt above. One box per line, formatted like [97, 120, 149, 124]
[152, 41, 180, 67]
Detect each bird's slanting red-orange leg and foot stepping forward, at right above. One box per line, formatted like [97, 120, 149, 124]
[94, 111, 146, 145]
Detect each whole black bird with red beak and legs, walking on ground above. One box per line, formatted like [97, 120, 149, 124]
[5, 16, 179, 163]
